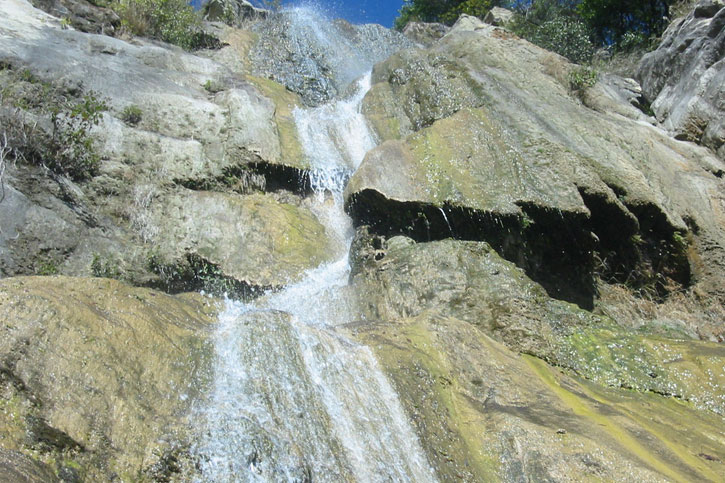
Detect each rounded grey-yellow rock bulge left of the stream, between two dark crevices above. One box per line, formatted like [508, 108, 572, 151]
[149, 190, 330, 294]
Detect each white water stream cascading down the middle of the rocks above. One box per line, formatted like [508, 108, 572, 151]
[196, 8, 435, 481]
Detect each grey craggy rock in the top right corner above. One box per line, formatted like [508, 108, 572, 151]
[637, 0, 725, 159]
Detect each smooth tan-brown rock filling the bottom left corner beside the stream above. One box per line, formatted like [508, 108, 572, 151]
[0, 277, 217, 481]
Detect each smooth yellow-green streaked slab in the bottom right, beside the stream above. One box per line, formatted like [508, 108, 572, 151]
[350, 311, 725, 482]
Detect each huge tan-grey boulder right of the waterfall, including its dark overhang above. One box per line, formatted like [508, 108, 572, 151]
[346, 17, 725, 314]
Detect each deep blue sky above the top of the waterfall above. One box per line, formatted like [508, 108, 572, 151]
[190, 0, 403, 27]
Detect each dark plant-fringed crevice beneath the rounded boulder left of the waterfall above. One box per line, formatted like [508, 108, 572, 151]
[147, 253, 278, 301]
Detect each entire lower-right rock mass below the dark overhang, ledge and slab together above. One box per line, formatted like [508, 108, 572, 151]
[351, 237, 725, 481]
